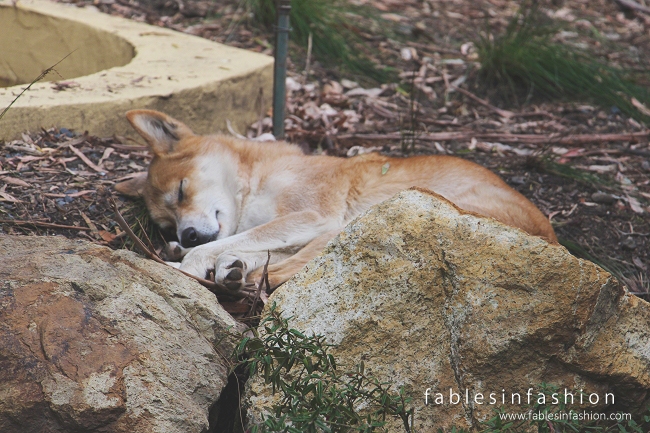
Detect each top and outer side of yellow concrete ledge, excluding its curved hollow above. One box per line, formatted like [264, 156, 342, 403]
[0, 0, 273, 140]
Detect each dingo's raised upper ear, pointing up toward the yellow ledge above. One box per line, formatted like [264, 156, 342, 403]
[126, 110, 194, 155]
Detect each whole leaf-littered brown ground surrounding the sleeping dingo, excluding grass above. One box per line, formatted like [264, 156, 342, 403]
[0, 0, 650, 306]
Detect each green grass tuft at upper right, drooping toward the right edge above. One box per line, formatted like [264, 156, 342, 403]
[476, 2, 650, 121]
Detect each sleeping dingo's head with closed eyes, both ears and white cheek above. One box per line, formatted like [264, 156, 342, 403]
[115, 110, 237, 247]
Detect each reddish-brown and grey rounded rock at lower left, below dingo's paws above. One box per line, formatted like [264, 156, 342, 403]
[0, 236, 243, 433]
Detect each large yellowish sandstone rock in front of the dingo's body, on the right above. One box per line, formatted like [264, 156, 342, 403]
[248, 190, 650, 432]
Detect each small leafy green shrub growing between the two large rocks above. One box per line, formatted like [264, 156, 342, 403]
[236, 306, 415, 433]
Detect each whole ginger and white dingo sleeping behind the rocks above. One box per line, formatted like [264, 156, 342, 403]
[116, 110, 556, 291]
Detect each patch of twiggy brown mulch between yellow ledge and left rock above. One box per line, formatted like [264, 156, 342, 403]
[0, 128, 150, 246]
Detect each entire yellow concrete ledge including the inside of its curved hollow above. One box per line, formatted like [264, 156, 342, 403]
[0, 0, 273, 140]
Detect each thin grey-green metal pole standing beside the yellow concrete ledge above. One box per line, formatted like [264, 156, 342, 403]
[273, 0, 291, 140]
